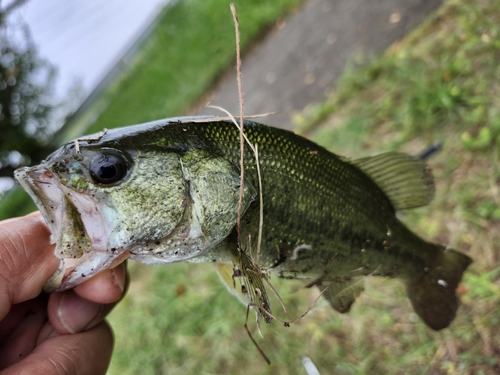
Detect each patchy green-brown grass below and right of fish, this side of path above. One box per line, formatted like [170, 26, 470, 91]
[110, 0, 500, 374]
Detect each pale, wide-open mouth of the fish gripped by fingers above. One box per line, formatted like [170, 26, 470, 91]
[15, 164, 128, 292]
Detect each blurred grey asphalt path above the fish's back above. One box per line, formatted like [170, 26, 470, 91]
[197, 0, 442, 129]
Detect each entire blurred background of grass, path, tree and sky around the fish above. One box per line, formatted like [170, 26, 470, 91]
[0, 0, 500, 374]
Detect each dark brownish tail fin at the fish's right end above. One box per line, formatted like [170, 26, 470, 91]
[406, 245, 472, 331]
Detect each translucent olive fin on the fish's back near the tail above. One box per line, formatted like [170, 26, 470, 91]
[351, 152, 434, 211]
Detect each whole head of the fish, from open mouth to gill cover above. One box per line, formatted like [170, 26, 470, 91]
[15, 122, 255, 291]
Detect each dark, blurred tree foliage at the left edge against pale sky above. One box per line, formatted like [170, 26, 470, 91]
[0, 10, 54, 180]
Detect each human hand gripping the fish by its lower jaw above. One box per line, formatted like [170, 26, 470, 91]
[0, 213, 127, 375]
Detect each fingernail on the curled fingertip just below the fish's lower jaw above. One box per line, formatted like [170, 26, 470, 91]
[57, 291, 104, 333]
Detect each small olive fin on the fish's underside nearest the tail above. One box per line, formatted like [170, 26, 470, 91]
[318, 279, 365, 314]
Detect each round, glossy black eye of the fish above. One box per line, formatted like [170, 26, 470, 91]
[89, 154, 128, 185]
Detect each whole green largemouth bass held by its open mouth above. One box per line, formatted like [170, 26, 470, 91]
[15, 117, 472, 330]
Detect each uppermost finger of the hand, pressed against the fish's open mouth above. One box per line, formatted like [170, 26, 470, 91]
[0, 213, 59, 319]
